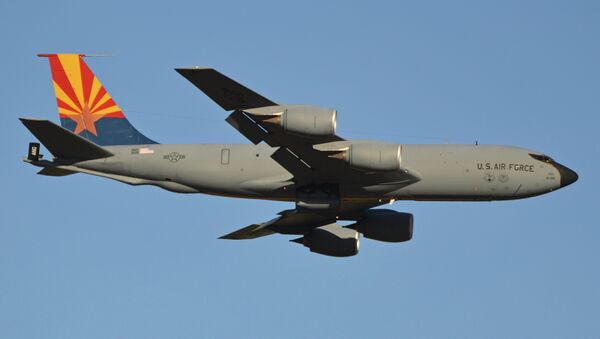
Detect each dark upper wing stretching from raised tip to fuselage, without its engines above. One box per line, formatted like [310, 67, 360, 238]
[176, 68, 418, 184]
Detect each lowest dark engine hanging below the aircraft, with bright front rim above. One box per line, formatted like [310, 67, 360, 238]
[292, 224, 360, 257]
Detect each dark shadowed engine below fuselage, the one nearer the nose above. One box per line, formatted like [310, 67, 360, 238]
[348, 209, 413, 242]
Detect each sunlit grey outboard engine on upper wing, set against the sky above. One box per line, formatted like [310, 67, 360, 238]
[245, 105, 337, 138]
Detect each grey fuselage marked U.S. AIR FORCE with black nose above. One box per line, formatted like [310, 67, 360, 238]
[74, 144, 574, 201]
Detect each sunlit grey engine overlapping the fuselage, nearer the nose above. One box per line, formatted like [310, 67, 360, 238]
[331, 142, 402, 171]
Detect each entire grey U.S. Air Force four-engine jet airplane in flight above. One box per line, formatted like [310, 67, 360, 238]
[20, 54, 578, 257]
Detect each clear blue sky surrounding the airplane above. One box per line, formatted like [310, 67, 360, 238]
[0, 1, 600, 339]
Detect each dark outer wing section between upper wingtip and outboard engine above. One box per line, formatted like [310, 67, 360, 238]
[175, 67, 277, 111]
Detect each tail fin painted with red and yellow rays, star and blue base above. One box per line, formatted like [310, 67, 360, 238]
[38, 54, 156, 145]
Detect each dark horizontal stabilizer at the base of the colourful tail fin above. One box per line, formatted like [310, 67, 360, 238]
[20, 118, 113, 160]
